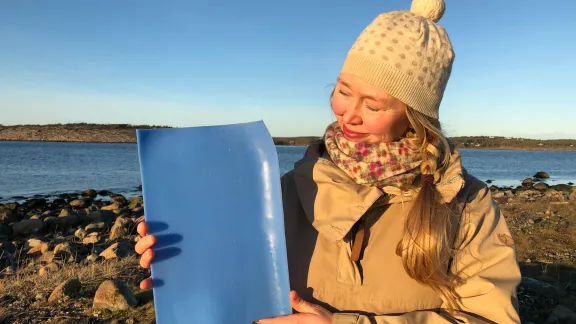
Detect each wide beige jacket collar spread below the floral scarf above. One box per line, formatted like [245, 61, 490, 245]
[293, 143, 465, 242]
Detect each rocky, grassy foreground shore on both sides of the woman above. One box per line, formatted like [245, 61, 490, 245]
[0, 178, 576, 323]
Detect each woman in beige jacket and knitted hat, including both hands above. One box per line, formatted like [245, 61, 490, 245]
[136, 0, 520, 324]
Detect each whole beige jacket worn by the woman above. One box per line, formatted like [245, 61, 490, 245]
[282, 145, 521, 324]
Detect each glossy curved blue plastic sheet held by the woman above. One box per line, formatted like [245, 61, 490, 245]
[137, 121, 292, 324]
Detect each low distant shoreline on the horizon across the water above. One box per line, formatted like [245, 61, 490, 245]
[0, 123, 576, 152]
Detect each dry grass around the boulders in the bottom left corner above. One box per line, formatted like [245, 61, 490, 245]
[0, 256, 155, 324]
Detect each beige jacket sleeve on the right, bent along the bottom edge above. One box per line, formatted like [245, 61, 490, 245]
[333, 186, 521, 324]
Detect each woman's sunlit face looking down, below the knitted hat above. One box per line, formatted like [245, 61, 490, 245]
[332, 74, 410, 143]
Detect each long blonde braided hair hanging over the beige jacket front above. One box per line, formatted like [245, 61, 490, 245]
[399, 108, 459, 311]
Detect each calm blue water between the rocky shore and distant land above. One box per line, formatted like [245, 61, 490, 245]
[0, 142, 576, 200]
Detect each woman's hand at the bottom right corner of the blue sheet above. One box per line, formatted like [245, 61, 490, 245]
[255, 291, 332, 324]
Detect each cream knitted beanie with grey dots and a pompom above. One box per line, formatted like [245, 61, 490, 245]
[341, 0, 454, 119]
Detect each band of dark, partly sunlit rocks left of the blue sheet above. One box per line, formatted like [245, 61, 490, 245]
[0, 189, 143, 275]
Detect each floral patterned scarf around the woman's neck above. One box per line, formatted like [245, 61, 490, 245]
[324, 122, 422, 189]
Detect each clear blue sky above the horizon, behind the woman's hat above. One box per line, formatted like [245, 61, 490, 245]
[0, 0, 576, 138]
